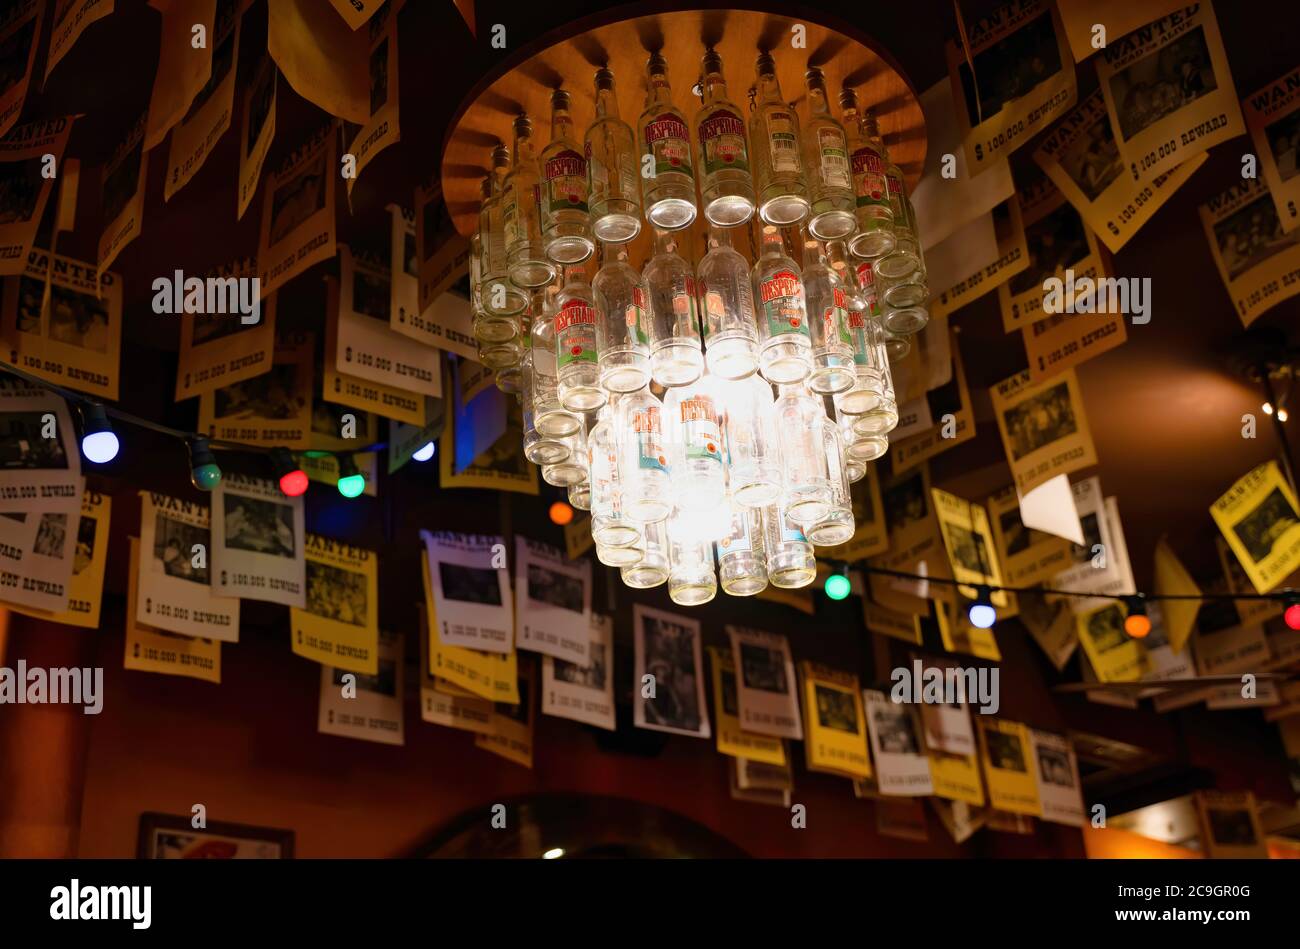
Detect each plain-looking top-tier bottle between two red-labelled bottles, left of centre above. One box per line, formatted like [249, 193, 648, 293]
[585, 66, 641, 244]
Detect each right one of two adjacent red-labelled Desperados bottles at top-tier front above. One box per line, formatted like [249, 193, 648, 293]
[696, 47, 754, 228]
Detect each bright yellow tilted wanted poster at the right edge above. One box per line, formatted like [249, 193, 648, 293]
[1210, 462, 1300, 593]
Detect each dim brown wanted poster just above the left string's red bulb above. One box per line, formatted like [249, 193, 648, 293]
[199, 332, 316, 451]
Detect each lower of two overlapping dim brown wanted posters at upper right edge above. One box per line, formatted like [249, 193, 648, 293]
[1200, 178, 1300, 326]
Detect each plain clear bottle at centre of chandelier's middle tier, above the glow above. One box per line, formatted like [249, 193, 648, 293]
[696, 224, 758, 380]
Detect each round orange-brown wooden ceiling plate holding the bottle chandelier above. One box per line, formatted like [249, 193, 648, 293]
[442, 7, 926, 237]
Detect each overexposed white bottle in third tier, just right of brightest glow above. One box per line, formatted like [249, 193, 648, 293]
[716, 373, 781, 507]
